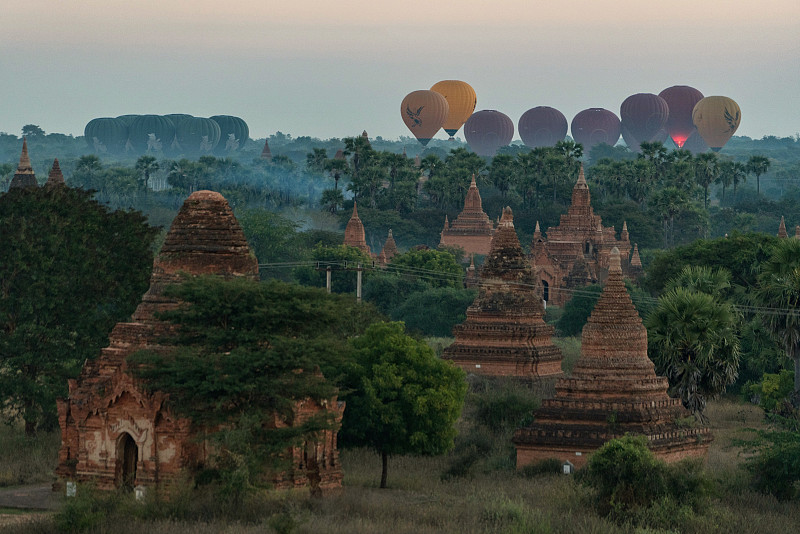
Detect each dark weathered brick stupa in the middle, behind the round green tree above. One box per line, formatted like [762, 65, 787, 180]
[442, 208, 562, 379]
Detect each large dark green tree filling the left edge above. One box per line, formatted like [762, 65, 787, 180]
[0, 187, 157, 434]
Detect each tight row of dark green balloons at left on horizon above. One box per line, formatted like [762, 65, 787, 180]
[83, 113, 250, 156]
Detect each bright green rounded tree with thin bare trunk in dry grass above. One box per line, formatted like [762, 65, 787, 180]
[340, 323, 467, 488]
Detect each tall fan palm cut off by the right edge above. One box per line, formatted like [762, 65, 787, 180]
[752, 239, 800, 406]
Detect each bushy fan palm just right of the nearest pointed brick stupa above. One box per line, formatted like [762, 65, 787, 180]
[645, 271, 741, 421]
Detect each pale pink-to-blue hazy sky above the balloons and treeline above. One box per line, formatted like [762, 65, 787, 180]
[0, 0, 800, 139]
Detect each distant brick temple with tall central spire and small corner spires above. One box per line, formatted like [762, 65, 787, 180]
[531, 166, 631, 306]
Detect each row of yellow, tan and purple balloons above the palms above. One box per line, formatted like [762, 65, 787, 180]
[400, 80, 741, 156]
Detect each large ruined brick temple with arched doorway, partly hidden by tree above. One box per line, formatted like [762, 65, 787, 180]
[56, 191, 344, 491]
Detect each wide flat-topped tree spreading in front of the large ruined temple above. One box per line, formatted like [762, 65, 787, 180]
[128, 276, 375, 495]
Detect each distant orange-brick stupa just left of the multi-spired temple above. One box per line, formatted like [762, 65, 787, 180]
[439, 174, 494, 255]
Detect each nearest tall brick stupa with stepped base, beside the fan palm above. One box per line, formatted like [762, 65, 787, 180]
[513, 248, 712, 468]
